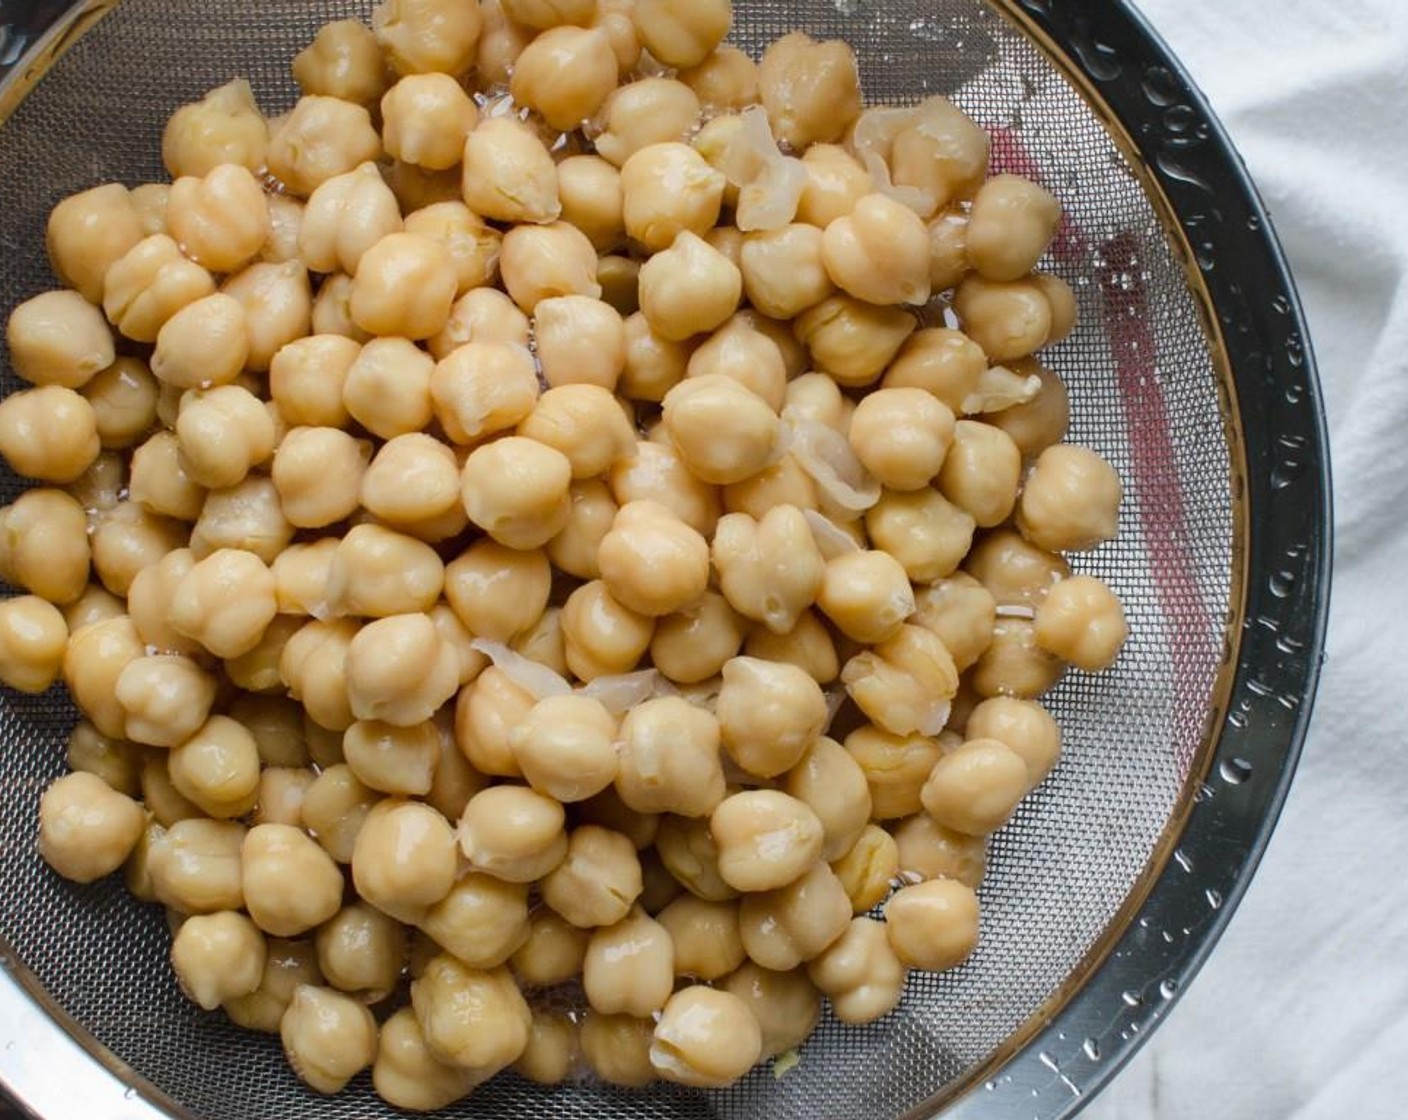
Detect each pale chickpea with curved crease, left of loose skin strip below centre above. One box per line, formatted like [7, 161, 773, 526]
[346, 614, 459, 727]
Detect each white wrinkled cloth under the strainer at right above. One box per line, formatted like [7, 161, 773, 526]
[1086, 0, 1408, 1120]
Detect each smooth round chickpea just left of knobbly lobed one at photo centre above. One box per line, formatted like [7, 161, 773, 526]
[597, 502, 710, 618]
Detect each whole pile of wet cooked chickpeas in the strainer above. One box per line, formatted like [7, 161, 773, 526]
[0, 0, 1126, 1110]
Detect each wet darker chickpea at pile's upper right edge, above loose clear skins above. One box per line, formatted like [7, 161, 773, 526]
[758, 31, 860, 152]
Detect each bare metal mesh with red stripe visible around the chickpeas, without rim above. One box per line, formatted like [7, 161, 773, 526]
[0, 0, 1232, 1120]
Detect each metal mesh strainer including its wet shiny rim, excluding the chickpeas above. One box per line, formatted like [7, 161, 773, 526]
[0, 0, 1329, 1120]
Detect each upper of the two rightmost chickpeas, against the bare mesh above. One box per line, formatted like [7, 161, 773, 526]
[1017, 444, 1124, 552]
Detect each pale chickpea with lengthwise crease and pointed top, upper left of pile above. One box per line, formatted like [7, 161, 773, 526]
[298, 161, 405, 275]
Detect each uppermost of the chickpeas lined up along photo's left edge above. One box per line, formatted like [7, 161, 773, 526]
[6, 292, 117, 389]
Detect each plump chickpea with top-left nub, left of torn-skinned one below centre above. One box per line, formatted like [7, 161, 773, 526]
[717, 657, 828, 778]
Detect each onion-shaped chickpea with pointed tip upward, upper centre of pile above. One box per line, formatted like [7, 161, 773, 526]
[641, 230, 743, 342]
